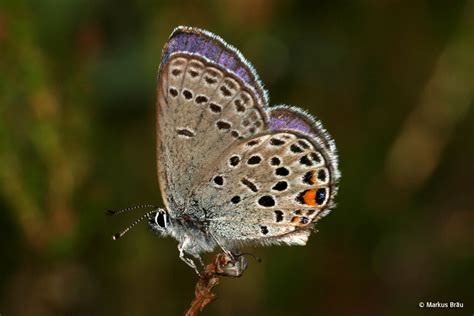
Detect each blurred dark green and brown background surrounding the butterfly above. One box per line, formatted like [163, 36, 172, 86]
[0, 0, 474, 315]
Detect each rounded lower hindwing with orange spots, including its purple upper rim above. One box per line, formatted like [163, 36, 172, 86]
[194, 106, 339, 247]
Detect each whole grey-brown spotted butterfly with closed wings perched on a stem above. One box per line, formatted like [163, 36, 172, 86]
[111, 26, 340, 276]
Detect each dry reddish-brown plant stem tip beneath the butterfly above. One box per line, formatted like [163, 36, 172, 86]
[185, 259, 223, 316]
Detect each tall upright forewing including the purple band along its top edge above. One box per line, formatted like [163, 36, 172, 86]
[157, 27, 268, 216]
